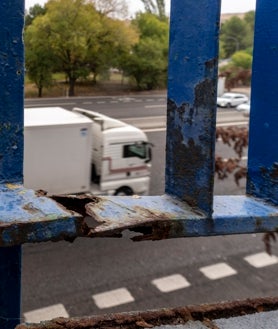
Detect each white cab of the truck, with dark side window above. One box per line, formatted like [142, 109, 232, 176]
[73, 108, 152, 195]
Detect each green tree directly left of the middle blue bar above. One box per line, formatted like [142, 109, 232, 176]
[122, 13, 169, 90]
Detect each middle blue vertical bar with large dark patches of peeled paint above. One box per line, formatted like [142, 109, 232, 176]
[166, 0, 221, 216]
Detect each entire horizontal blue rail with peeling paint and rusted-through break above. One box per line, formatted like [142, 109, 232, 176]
[0, 188, 278, 246]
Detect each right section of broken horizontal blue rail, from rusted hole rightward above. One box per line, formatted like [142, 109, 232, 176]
[53, 195, 278, 241]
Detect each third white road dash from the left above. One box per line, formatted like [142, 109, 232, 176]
[152, 274, 190, 292]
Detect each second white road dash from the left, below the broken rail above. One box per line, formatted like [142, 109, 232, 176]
[92, 288, 134, 309]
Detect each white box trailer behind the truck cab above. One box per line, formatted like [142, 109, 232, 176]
[23, 107, 92, 194]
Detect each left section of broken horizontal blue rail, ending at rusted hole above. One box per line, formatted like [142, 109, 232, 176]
[0, 184, 86, 247]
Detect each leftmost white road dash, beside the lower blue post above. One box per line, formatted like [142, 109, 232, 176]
[23, 304, 69, 323]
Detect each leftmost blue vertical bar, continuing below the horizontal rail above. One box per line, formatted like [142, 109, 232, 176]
[0, 0, 24, 329]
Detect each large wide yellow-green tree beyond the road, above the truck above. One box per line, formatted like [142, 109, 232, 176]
[25, 0, 137, 96]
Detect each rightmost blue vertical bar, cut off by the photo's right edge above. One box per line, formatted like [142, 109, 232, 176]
[247, 0, 278, 204]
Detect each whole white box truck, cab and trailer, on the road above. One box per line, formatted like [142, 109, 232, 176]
[23, 107, 151, 195]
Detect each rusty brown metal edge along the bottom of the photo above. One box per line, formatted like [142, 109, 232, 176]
[16, 297, 278, 329]
